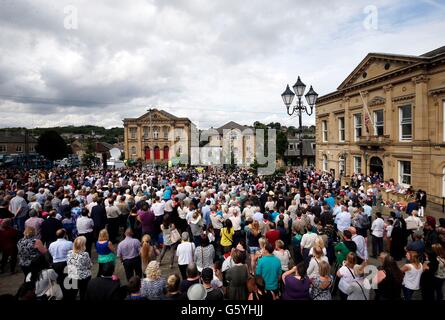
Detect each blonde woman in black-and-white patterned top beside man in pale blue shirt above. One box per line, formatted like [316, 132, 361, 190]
[66, 236, 93, 300]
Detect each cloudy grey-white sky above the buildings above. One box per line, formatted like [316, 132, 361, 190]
[0, 0, 445, 128]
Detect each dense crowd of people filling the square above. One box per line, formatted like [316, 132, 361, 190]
[0, 168, 445, 300]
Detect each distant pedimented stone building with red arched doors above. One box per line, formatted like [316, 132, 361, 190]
[123, 109, 196, 164]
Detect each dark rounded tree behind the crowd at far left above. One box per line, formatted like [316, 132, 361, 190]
[36, 130, 69, 161]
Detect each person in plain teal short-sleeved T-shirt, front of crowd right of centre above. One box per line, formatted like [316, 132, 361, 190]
[256, 243, 281, 291]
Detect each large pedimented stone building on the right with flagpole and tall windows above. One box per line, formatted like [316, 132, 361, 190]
[316, 47, 445, 203]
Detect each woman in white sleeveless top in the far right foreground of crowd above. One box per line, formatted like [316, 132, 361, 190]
[400, 251, 423, 300]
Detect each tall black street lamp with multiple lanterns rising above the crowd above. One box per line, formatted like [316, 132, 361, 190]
[281, 77, 318, 196]
